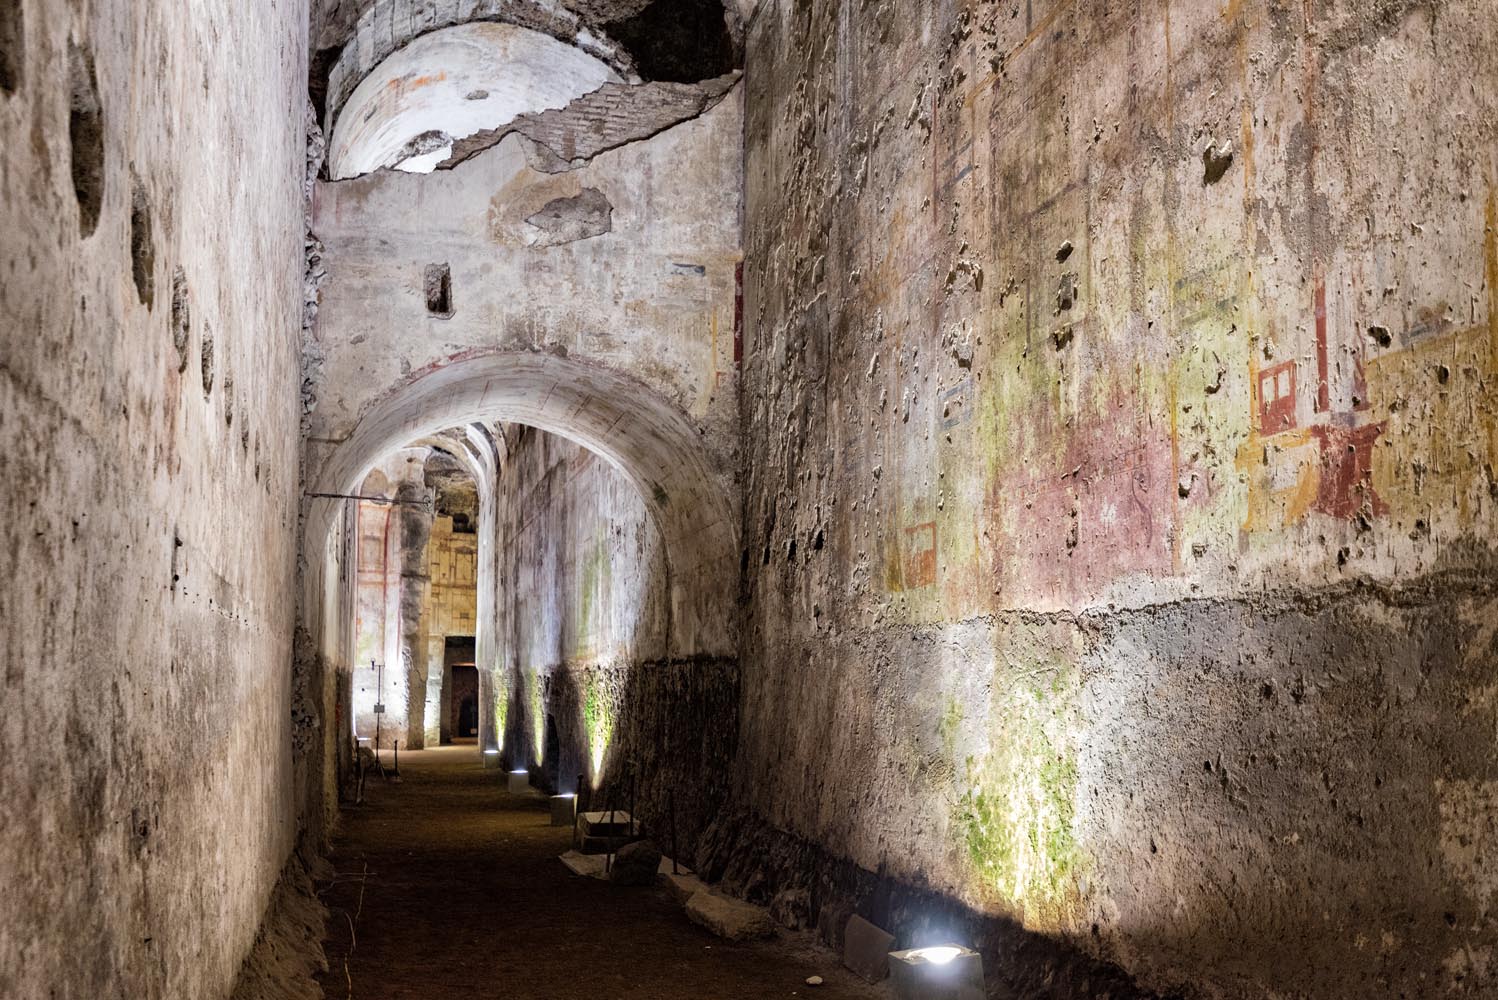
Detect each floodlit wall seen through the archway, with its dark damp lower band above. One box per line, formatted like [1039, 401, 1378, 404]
[487, 427, 737, 850]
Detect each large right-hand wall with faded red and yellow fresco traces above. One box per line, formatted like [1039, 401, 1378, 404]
[739, 0, 1498, 999]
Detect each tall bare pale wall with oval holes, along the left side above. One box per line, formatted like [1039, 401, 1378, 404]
[0, 0, 307, 999]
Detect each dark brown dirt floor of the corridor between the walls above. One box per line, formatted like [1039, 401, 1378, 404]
[310, 746, 890, 1000]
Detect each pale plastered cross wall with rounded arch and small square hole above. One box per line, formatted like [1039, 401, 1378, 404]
[307, 83, 740, 657]
